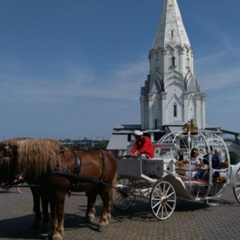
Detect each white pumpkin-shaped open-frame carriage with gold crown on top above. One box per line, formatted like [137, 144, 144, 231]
[114, 125, 240, 220]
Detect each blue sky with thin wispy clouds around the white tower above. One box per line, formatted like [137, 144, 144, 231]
[0, 0, 240, 139]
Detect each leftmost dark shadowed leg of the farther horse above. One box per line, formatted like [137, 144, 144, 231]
[30, 187, 42, 230]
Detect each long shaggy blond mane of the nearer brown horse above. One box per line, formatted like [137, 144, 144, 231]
[15, 139, 61, 178]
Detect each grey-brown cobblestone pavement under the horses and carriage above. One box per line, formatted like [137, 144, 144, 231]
[0, 187, 240, 240]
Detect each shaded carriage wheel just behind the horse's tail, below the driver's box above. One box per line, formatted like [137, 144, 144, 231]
[113, 177, 136, 211]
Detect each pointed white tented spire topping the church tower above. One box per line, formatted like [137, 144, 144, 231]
[152, 0, 190, 49]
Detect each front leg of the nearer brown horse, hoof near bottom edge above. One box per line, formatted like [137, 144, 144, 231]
[48, 189, 65, 240]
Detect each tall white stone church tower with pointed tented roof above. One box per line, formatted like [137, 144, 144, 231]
[140, 0, 206, 134]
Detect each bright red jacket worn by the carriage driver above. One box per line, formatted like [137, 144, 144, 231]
[131, 136, 154, 158]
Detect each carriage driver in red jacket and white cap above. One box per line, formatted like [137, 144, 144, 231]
[129, 130, 154, 158]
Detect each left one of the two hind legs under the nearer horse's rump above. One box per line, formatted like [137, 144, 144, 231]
[85, 190, 97, 223]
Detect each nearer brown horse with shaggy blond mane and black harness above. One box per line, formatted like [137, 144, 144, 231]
[2, 139, 117, 239]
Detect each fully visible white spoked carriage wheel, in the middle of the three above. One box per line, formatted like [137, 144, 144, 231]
[150, 181, 177, 220]
